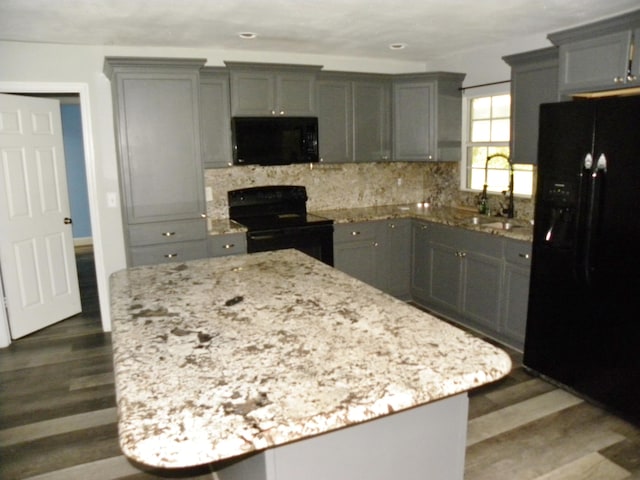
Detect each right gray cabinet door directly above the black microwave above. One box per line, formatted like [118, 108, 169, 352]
[276, 73, 316, 117]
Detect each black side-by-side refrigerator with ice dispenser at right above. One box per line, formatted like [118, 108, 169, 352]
[523, 96, 640, 424]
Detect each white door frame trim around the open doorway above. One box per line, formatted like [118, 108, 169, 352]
[0, 82, 108, 348]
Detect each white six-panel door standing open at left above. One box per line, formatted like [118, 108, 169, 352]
[0, 94, 81, 338]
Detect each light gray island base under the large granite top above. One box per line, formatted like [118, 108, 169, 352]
[216, 393, 469, 480]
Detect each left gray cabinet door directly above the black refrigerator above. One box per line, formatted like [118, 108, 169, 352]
[559, 30, 632, 92]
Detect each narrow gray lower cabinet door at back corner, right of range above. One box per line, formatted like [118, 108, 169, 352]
[378, 219, 411, 298]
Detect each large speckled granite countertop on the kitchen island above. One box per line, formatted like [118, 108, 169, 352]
[110, 250, 511, 468]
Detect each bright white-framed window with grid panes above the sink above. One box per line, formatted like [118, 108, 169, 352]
[462, 93, 533, 197]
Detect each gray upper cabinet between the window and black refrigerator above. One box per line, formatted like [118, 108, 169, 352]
[503, 47, 559, 165]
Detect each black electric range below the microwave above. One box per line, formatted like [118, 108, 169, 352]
[227, 185, 333, 266]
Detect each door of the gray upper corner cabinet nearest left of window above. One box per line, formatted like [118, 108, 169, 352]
[393, 82, 435, 161]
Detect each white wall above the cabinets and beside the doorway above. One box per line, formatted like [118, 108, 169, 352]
[0, 33, 549, 338]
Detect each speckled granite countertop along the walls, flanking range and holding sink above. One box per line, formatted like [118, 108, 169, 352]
[209, 204, 533, 242]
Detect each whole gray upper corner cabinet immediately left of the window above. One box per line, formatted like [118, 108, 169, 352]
[393, 72, 465, 161]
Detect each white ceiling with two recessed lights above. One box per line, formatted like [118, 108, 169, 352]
[0, 0, 638, 62]
